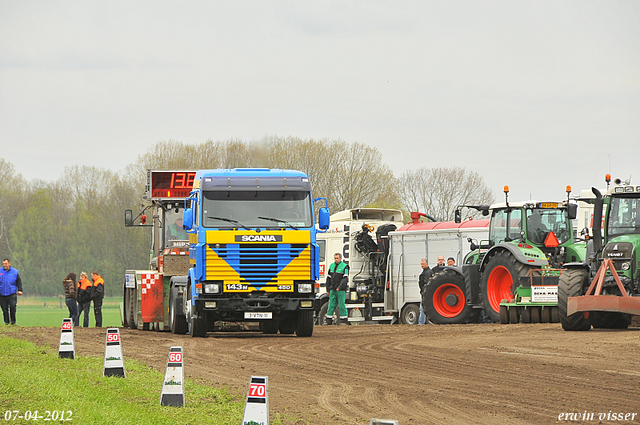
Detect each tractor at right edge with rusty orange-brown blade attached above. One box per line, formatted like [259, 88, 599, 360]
[558, 175, 640, 331]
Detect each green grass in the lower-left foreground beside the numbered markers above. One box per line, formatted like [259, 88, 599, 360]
[0, 327, 248, 425]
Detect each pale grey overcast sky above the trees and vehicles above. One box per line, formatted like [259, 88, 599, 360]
[0, 0, 640, 201]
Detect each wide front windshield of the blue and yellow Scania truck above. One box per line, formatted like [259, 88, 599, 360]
[202, 191, 313, 229]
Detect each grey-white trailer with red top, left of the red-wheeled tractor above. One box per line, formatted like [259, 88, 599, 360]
[384, 219, 489, 324]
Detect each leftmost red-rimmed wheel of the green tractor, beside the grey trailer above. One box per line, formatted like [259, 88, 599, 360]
[418, 270, 480, 325]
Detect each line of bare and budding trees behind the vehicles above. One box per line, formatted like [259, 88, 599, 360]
[0, 137, 493, 296]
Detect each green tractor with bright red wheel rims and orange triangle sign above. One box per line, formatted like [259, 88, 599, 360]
[423, 186, 586, 324]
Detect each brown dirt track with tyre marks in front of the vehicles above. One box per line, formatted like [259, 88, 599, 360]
[5, 324, 640, 425]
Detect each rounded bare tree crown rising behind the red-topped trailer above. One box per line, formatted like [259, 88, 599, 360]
[400, 167, 494, 221]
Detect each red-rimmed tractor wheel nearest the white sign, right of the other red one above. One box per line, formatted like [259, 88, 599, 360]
[482, 251, 531, 322]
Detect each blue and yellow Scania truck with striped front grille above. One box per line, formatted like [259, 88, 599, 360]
[169, 168, 329, 337]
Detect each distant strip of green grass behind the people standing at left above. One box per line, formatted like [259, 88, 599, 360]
[12, 297, 122, 328]
